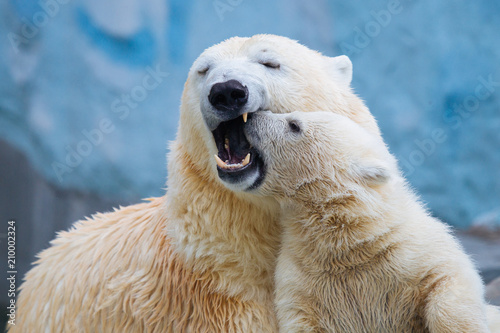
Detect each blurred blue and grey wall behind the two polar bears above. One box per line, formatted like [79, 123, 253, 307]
[0, 0, 500, 322]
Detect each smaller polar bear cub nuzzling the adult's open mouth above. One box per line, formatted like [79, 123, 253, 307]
[245, 112, 498, 332]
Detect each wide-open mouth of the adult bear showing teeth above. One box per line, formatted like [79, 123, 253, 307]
[212, 113, 264, 190]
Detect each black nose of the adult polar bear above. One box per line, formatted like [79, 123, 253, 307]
[208, 80, 248, 111]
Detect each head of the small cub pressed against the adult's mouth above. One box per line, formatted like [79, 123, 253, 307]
[245, 111, 397, 202]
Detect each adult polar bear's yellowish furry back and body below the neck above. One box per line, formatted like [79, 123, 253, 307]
[10, 198, 275, 333]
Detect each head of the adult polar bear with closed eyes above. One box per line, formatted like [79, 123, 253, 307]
[176, 35, 379, 191]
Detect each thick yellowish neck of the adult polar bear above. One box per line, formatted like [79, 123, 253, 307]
[167, 143, 281, 299]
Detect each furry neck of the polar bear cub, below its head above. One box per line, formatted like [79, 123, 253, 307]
[282, 185, 411, 272]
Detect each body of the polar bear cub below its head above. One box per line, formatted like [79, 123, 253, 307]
[276, 196, 487, 332]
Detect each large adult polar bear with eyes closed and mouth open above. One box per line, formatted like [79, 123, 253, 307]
[9, 35, 379, 332]
